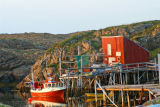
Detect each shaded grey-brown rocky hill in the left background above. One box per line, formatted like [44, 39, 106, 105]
[0, 33, 72, 87]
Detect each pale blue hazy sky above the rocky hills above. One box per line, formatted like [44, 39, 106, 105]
[0, 0, 160, 34]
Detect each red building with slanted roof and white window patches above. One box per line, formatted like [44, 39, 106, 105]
[102, 36, 149, 65]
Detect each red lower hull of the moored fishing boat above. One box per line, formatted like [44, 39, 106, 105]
[31, 90, 65, 97]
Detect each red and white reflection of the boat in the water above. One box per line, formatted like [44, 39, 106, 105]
[28, 97, 67, 107]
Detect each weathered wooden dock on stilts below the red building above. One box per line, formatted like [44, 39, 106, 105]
[59, 54, 160, 107]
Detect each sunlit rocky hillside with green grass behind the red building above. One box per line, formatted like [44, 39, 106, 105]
[17, 21, 160, 88]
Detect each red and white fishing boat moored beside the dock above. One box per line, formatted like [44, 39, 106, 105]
[31, 74, 66, 97]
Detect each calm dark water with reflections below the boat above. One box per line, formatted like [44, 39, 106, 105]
[0, 89, 102, 107]
